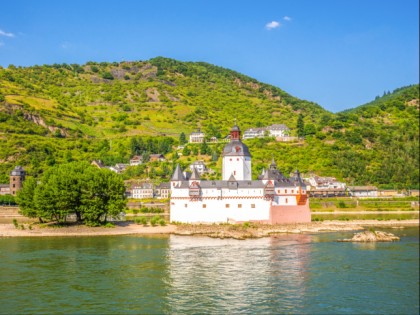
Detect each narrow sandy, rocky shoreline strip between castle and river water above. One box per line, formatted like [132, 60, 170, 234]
[0, 220, 419, 239]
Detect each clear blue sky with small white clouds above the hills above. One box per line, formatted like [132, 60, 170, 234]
[0, 0, 419, 112]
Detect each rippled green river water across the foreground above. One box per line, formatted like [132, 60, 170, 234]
[0, 228, 419, 314]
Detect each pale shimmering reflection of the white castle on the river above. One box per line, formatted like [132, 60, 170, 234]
[168, 235, 311, 313]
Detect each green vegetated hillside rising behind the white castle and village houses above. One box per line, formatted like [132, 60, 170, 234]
[0, 57, 419, 187]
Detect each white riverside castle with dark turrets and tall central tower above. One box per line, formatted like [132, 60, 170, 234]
[170, 125, 311, 224]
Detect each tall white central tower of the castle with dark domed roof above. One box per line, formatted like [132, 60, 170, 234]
[222, 125, 252, 181]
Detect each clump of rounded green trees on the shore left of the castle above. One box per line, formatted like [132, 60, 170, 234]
[17, 162, 126, 225]
